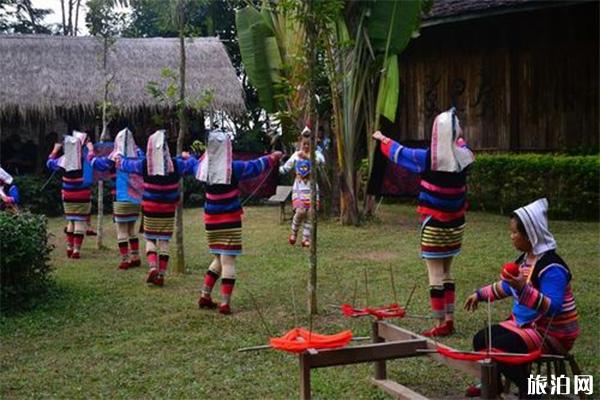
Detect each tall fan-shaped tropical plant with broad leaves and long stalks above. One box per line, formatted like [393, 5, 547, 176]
[236, 0, 429, 224]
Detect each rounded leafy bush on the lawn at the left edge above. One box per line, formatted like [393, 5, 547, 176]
[0, 212, 52, 311]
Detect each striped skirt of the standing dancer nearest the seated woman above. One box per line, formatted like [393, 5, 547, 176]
[421, 216, 465, 258]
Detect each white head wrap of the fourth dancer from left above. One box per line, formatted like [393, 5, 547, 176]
[196, 130, 233, 185]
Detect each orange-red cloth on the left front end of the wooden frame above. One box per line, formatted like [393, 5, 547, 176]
[269, 328, 352, 353]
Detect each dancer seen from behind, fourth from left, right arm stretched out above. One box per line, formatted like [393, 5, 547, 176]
[196, 131, 281, 314]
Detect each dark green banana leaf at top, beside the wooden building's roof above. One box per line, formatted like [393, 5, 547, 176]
[367, 0, 421, 54]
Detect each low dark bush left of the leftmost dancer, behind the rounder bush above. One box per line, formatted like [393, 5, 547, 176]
[14, 174, 63, 217]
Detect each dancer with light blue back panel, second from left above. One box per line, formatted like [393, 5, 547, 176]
[88, 129, 144, 269]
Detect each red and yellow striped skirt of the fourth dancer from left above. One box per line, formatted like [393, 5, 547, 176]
[204, 210, 242, 256]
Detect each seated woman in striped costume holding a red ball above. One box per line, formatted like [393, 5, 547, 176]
[465, 199, 579, 398]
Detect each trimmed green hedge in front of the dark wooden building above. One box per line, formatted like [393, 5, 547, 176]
[469, 154, 600, 220]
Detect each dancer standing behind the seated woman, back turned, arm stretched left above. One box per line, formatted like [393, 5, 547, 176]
[373, 109, 474, 336]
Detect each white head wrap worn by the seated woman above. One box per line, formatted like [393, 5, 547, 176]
[515, 198, 556, 256]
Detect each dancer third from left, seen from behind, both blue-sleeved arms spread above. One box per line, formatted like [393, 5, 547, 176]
[115, 130, 196, 286]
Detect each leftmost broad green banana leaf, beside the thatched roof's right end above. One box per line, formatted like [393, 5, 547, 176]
[235, 6, 281, 112]
